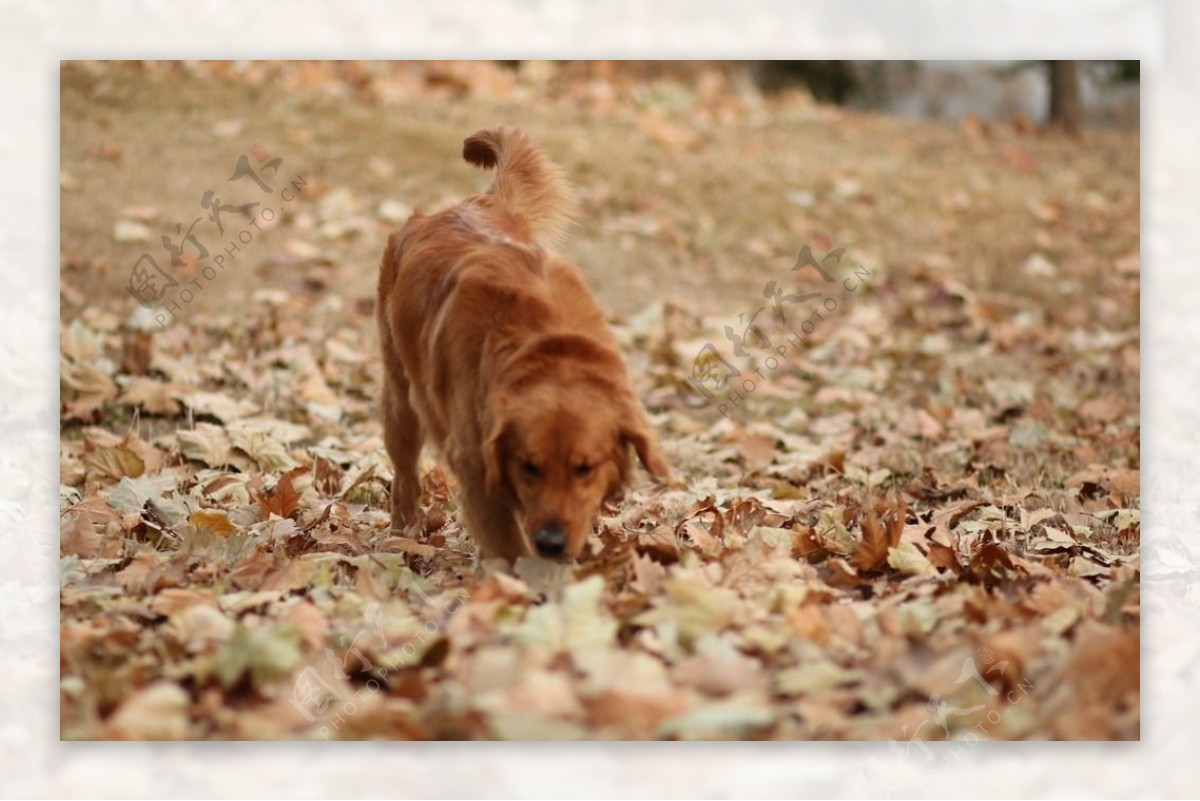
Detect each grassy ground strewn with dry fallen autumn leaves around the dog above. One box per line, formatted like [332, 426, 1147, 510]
[60, 65, 1140, 738]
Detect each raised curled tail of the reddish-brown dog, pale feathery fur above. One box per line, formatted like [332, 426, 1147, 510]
[462, 126, 578, 245]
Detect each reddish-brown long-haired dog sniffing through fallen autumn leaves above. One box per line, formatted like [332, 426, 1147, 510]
[376, 127, 670, 562]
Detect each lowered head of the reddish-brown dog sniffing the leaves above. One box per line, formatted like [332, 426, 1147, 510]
[484, 335, 670, 559]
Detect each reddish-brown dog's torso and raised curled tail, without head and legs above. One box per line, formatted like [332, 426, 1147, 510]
[377, 127, 600, 470]
